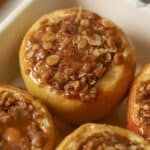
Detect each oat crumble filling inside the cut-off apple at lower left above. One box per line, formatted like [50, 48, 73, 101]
[0, 91, 48, 150]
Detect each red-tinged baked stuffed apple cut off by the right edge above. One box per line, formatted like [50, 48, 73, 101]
[127, 64, 150, 140]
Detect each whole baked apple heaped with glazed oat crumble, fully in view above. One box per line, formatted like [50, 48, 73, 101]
[20, 8, 135, 123]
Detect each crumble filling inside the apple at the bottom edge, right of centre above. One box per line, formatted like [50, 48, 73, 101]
[78, 131, 144, 150]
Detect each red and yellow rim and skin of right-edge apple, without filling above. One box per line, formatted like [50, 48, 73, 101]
[127, 64, 150, 138]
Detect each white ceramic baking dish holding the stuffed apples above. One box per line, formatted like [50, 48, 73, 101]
[0, 0, 150, 129]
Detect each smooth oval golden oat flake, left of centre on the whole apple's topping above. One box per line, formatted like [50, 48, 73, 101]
[46, 55, 60, 66]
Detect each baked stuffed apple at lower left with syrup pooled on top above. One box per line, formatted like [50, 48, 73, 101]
[0, 84, 55, 150]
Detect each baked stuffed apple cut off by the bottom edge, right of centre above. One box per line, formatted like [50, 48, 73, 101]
[56, 124, 150, 150]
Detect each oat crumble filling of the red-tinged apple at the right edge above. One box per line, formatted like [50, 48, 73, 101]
[137, 80, 150, 139]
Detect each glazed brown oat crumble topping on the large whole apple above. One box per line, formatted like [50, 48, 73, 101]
[25, 8, 124, 102]
